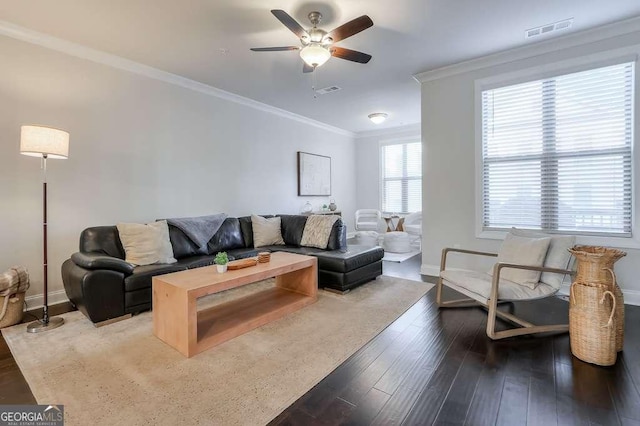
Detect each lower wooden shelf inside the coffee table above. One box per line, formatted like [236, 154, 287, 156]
[196, 287, 316, 352]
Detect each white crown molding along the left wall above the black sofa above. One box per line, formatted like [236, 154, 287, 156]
[0, 20, 355, 137]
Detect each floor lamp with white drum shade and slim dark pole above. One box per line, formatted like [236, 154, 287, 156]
[20, 126, 69, 333]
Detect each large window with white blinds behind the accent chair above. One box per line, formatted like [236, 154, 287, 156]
[481, 62, 634, 237]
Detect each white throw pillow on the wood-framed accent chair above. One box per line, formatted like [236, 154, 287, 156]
[490, 234, 551, 289]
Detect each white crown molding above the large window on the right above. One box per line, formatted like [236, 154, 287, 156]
[413, 17, 640, 83]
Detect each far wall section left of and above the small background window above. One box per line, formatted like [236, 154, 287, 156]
[356, 124, 420, 213]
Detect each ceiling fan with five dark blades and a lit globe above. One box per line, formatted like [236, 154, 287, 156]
[251, 9, 373, 72]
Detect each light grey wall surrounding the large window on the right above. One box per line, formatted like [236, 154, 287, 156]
[419, 27, 640, 304]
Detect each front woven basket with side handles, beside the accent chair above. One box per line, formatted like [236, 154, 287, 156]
[569, 282, 617, 366]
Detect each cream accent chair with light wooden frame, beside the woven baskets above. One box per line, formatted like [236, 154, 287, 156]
[436, 230, 575, 340]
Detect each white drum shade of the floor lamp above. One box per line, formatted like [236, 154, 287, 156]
[20, 126, 69, 159]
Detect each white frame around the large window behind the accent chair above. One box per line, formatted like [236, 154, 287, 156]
[474, 51, 640, 248]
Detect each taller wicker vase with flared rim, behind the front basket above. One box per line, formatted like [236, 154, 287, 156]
[569, 246, 627, 352]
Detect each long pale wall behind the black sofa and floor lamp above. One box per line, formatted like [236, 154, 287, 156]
[0, 37, 356, 302]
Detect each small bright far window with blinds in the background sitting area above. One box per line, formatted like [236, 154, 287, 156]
[380, 142, 422, 213]
